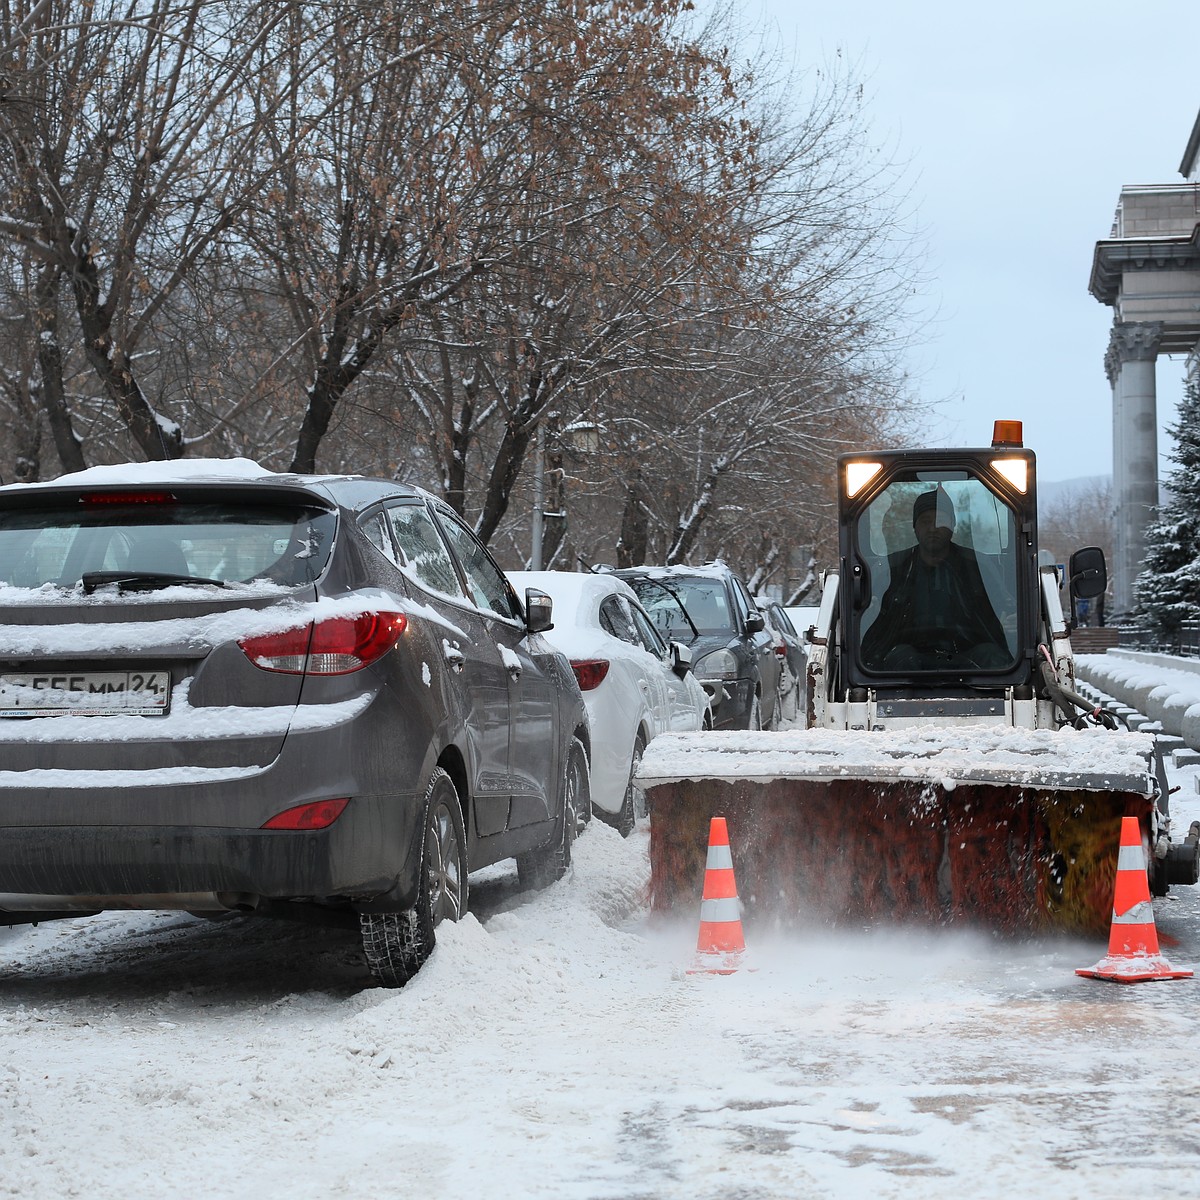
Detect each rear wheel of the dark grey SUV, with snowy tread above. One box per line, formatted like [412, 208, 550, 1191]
[359, 767, 467, 988]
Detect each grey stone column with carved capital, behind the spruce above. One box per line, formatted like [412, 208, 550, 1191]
[1104, 320, 1163, 618]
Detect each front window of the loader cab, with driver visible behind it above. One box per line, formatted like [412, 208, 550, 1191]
[854, 472, 1018, 676]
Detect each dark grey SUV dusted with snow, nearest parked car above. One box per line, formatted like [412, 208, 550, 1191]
[0, 460, 589, 985]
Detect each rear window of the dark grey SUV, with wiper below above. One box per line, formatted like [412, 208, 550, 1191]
[0, 497, 336, 589]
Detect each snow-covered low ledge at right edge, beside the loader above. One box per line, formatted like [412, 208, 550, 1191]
[1075, 649, 1200, 750]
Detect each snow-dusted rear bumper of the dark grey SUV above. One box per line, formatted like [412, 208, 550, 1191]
[0, 691, 428, 912]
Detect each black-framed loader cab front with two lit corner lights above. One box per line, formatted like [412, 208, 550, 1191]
[830, 443, 1039, 698]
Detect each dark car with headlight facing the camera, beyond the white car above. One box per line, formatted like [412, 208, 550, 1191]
[613, 563, 780, 730]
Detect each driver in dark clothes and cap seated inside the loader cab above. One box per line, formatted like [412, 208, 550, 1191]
[863, 487, 1012, 671]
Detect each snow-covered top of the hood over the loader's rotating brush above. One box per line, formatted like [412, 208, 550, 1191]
[638, 725, 1153, 796]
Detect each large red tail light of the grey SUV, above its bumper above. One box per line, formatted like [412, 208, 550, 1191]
[238, 612, 408, 674]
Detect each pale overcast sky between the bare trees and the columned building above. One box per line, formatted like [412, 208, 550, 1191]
[697, 0, 1200, 481]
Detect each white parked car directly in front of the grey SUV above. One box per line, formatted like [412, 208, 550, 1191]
[509, 571, 709, 838]
